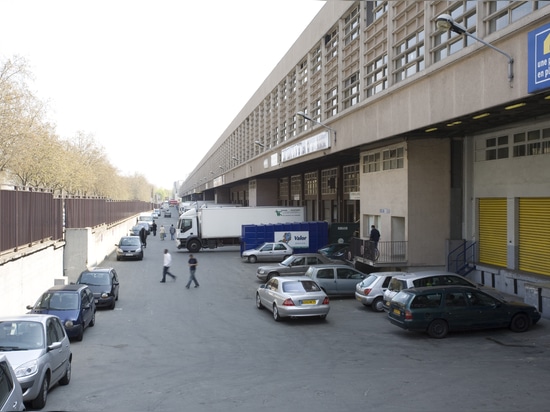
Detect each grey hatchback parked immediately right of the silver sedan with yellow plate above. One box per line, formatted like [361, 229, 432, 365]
[305, 263, 366, 296]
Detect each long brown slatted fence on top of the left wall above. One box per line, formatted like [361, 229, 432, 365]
[0, 190, 152, 252]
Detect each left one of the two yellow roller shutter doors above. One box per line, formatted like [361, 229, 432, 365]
[478, 198, 507, 267]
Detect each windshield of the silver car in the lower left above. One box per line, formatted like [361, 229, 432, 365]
[0, 321, 44, 351]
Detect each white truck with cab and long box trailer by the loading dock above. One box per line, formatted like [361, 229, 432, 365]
[176, 206, 305, 253]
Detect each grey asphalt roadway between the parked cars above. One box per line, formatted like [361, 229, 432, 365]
[41, 214, 550, 412]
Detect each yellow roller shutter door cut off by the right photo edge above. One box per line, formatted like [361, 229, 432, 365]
[518, 198, 550, 275]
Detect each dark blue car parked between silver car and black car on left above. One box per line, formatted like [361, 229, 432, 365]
[27, 285, 96, 341]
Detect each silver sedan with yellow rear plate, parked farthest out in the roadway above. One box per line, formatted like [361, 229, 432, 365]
[256, 276, 330, 321]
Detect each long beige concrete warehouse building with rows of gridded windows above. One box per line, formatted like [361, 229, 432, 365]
[179, 1, 550, 301]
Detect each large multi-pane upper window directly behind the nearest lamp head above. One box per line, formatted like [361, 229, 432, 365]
[432, 1, 477, 62]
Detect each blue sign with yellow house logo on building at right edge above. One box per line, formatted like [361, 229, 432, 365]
[527, 24, 550, 93]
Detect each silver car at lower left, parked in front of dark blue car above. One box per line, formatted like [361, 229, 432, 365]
[0, 314, 73, 409]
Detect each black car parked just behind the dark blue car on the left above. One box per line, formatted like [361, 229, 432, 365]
[76, 267, 119, 309]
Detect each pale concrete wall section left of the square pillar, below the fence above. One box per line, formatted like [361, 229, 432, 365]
[0, 242, 67, 316]
